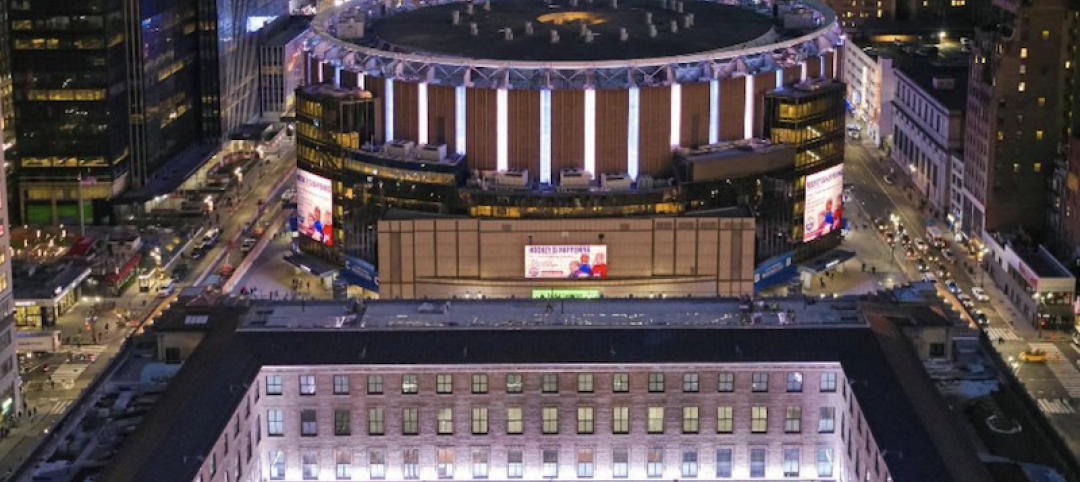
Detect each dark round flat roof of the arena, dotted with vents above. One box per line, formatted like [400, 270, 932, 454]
[373, 0, 772, 61]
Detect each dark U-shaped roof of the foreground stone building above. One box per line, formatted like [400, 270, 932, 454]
[100, 300, 989, 482]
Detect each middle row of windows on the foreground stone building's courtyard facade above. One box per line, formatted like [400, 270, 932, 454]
[267, 405, 836, 437]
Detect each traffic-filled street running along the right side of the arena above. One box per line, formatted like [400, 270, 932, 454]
[843, 125, 1080, 453]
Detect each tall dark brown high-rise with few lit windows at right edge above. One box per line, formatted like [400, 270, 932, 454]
[961, 0, 1078, 242]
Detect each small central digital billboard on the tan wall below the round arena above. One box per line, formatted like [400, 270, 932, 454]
[525, 244, 607, 279]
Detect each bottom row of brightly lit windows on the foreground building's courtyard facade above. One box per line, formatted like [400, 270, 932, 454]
[267, 445, 835, 480]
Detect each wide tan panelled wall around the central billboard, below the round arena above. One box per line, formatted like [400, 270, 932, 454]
[378, 217, 754, 299]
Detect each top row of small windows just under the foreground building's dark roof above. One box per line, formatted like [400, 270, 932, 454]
[266, 372, 837, 396]
